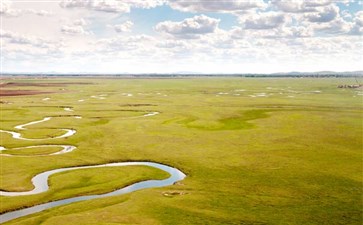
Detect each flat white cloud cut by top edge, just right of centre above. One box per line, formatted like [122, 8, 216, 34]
[168, 0, 266, 12]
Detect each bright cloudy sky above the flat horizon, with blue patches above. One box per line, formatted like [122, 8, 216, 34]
[0, 0, 363, 74]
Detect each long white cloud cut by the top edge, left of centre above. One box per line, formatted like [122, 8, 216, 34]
[59, 0, 164, 13]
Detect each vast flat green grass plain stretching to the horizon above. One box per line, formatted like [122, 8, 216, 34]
[0, 78, 363, 225]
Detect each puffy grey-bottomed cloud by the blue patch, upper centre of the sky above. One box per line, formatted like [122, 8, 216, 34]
[155, 15, 220, 38]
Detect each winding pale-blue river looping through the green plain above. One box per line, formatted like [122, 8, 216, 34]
[0, 112, 186, 223]
